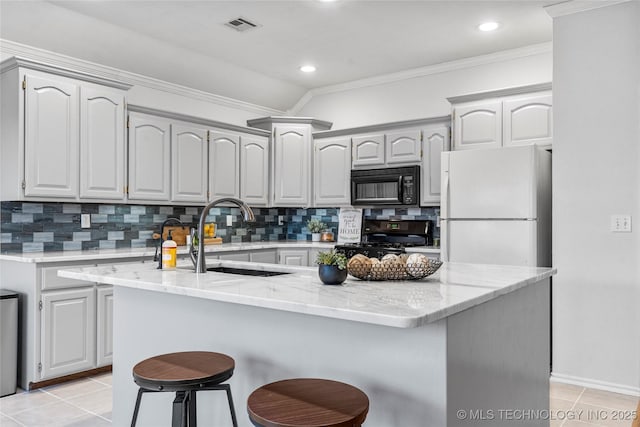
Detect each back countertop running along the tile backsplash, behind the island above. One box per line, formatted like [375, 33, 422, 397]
[0, 240, 440, 263]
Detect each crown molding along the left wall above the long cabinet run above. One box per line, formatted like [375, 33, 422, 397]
[0, 39, 284, 115]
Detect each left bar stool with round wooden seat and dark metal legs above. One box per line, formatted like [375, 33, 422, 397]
[131, 351, 238, 427]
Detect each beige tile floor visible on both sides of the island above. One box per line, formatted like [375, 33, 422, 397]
[0, 373, 639, 427]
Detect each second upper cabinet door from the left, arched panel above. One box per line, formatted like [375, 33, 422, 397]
[80, 86, 124, 200]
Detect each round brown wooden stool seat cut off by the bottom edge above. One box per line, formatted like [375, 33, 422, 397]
[247, 378, 369, 427]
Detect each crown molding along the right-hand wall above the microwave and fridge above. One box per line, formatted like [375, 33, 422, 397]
[287, 42, 553, 115]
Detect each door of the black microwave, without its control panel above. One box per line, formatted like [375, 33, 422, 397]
[351, 169, 403, 206]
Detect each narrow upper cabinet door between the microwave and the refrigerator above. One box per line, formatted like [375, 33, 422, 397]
[420, 126, 449, 206]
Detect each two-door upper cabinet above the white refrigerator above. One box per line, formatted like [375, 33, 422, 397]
[448, 83, 553, 150]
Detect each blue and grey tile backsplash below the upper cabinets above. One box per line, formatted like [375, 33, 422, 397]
[0, 202, 439, 253]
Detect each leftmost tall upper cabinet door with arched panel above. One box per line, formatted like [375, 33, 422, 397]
[23, 74, 79, 198]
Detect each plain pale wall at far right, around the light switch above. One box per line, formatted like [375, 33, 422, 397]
[553, 1, 640, 394]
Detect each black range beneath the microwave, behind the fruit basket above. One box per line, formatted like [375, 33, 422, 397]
[335, 219, 433, 259]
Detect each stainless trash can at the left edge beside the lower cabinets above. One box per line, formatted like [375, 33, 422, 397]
[0, 289, 18, 397]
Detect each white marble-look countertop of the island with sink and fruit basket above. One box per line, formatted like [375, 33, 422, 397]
[58, 261, 555, 328]
